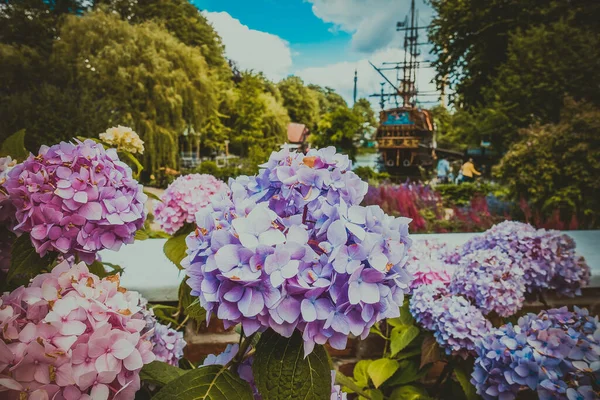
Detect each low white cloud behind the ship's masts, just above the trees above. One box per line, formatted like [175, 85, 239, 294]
[295, 48, 437, 110]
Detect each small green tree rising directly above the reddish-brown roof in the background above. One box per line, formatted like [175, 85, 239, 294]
[277, 76, 319, 131]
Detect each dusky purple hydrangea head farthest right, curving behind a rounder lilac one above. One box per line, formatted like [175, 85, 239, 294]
[461, 221, 590, 297]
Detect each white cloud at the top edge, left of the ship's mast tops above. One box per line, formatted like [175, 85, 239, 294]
[307, 0, 431, 53]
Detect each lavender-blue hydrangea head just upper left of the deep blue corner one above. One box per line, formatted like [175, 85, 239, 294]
[410, 282, 492, 358]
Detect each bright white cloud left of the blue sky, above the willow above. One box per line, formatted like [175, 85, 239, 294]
[203, 11, 292, 80]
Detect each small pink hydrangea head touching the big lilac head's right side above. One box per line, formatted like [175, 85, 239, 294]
[407, 239, 456, 290]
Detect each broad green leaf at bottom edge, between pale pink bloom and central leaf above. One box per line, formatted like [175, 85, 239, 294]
[152, 365, 253, 400]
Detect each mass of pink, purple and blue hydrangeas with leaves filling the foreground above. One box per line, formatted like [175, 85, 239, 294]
[0, 131, 600, 400]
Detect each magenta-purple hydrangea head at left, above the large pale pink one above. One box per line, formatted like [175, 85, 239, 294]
[4, 140, 147, 262]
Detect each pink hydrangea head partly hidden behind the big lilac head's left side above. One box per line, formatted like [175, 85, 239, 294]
[154, 174, 229, 235]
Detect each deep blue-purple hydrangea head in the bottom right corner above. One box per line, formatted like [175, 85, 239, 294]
[471, 307, 600, 400]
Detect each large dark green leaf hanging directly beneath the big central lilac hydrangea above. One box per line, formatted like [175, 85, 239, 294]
[252, 330, 331, 400]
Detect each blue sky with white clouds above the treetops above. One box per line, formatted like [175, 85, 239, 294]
[191, 0, 433, 107]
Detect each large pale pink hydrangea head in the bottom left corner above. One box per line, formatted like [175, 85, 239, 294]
[0, 261, 155, 400]
